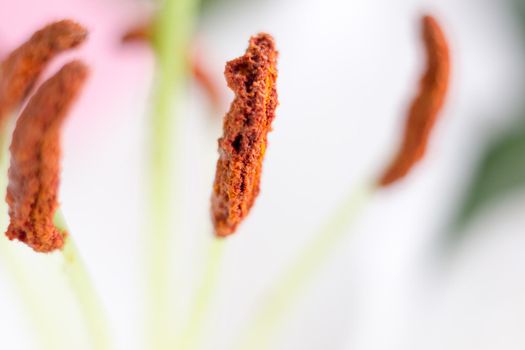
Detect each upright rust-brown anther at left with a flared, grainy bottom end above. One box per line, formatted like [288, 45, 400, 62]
[6, 61, 88, 252]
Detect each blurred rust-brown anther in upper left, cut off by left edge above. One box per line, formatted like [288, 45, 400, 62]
[0, 20, 87, 126]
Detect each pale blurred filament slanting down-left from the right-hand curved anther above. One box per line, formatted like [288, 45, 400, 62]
[234, 186, 373, 350]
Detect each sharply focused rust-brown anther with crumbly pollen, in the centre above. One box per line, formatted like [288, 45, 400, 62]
[212, 34, 278, 237]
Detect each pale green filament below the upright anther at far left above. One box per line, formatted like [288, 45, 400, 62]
[55, 210, 112, 350]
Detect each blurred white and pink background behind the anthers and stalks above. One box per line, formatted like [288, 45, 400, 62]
[0, 0, 525, 350]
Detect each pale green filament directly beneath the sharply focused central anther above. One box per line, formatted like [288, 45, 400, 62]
[175, 237, 226, 350]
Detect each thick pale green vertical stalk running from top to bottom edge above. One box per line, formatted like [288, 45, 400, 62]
[144, 0, 197, 350]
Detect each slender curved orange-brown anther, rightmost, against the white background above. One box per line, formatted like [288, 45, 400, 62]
[379, 16, 450, 187]
